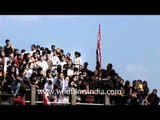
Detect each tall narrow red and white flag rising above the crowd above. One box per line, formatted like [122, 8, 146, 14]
[96, 25, 102, 69]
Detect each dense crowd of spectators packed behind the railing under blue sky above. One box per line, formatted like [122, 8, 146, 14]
[0, 39, 160, 105]
